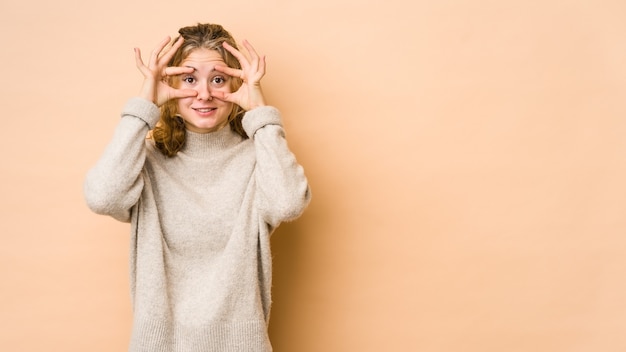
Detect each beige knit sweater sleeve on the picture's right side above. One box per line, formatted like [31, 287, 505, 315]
[243, 106, 311, 228]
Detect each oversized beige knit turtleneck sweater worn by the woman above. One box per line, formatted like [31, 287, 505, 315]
[84, 98, 310, 352]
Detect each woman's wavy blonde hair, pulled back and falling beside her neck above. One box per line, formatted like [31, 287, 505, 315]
[150, 23, 248, 157]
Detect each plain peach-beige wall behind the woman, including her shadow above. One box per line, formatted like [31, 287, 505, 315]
[0, 0, 626, 352]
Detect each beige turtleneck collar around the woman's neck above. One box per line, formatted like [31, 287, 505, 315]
[180, 125, 242, 157]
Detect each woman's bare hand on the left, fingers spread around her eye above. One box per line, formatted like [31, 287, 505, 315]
[135, 37, 198, 106]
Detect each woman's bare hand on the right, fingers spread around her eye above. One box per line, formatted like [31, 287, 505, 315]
[214, 40, 265, 111]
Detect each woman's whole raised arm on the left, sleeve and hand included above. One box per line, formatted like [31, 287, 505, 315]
[84, 37, 197, 221]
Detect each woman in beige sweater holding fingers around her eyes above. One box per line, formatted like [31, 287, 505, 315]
[85, 24, 310, 352]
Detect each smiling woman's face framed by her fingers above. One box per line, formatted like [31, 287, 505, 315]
[177, 49, 233, 133]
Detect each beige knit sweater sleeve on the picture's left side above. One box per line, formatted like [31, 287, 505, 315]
[83, 98, 159, 222]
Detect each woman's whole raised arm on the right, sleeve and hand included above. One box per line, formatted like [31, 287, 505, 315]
[214, 40, 311, 224]
